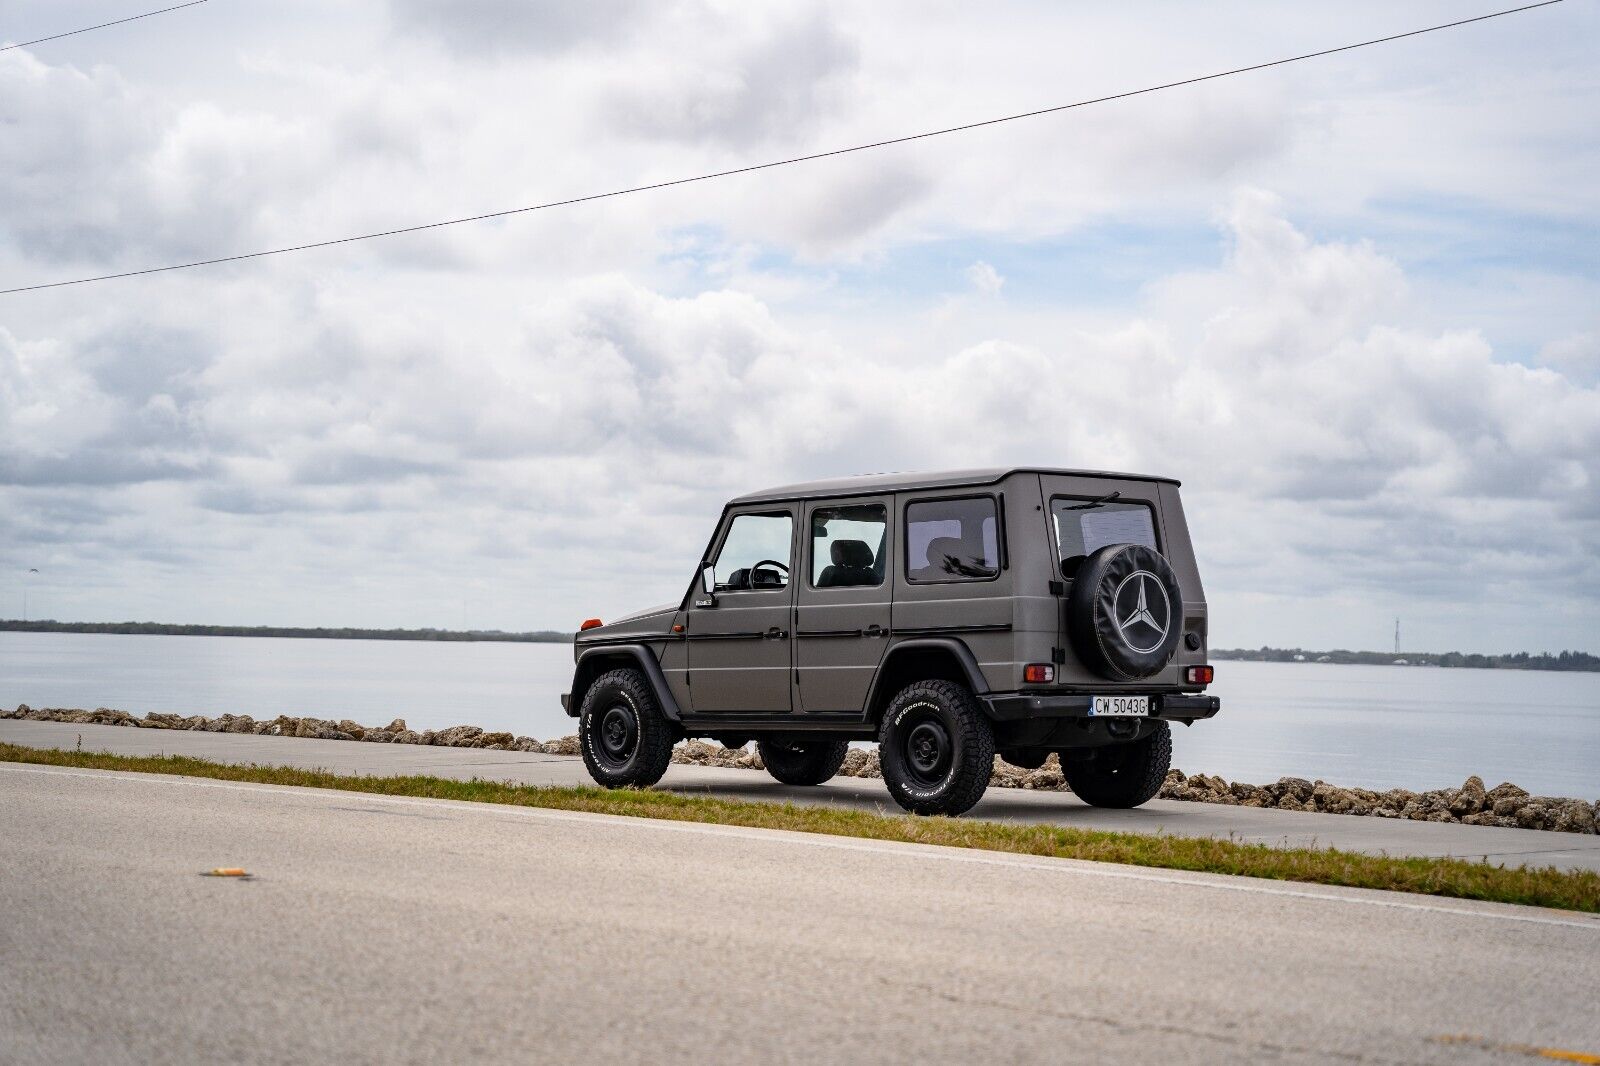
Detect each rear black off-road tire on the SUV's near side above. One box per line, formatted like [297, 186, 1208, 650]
[878, 680, 995, 815]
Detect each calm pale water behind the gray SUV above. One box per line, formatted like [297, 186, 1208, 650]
[0, 632, 1600, 799]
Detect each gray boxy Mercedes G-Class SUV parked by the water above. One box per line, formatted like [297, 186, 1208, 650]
[562, 467, 1219, 815]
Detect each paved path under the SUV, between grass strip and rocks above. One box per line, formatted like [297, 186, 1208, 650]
[0, 720, 1600, 871]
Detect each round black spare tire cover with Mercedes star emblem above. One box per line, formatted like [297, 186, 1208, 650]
[1067, 544, 1184, 682]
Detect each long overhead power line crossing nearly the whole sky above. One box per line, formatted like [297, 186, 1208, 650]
[0, 0, 1562, 296]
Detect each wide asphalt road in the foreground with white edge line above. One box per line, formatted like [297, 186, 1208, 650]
[0, 763, 1600, 1063]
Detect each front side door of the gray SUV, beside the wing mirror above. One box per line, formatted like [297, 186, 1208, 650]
[683, 504, 797, 714]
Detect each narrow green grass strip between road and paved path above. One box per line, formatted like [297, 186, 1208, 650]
[0, 744, 1600, 912]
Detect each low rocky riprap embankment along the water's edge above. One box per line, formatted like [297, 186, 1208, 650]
[0, 704, 1600, 832]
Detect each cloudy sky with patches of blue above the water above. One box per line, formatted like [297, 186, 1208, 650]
[0, 0, 1600, 651]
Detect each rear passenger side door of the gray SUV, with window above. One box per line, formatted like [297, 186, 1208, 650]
[795, 496, 894, 714]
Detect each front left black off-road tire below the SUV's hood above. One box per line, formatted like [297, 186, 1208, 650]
[578, 669, 674, 789]
